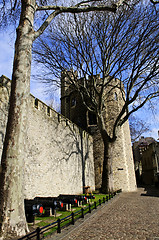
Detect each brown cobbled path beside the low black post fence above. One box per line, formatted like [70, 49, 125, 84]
[50, 188, 159, 240]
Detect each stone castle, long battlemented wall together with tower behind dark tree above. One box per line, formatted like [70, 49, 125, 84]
[0, 76, 136, 199]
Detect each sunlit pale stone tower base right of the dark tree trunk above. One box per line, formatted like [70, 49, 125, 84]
[110, 122, 136, 192]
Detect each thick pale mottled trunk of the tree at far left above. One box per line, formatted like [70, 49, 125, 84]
[0, 0, 35, 239]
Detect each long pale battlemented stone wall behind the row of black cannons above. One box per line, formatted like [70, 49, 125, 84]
[0, 77, 95, 198]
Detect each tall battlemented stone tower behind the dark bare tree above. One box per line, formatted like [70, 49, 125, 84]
[61, 72, 136, 191]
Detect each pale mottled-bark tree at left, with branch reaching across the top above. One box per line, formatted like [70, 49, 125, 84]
[0, 0, 130, 239]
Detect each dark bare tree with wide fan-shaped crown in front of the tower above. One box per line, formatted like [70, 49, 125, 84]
[34, 2, 159, 192]
